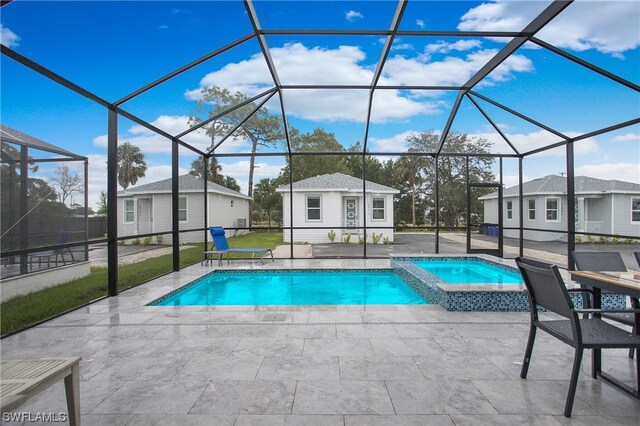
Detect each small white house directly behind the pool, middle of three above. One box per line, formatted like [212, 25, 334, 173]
[276, 173, 400, 243]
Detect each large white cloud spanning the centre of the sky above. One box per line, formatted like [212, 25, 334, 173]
[185, 41, 533, 123]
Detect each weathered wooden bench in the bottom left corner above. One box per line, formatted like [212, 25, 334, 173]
[0, 357, 82, 426]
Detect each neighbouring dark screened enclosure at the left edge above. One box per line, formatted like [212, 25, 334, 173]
[0, 125, 89, 300]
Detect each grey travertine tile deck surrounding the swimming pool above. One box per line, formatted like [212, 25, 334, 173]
[1, 259, 640, 426]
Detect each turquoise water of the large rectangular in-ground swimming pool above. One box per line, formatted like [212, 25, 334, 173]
[151, 270, 427, 306]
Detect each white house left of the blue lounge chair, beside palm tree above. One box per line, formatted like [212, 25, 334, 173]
[118, 175, 251, 243]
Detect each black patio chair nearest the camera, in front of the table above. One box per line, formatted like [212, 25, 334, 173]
[516, 257, 640, 417]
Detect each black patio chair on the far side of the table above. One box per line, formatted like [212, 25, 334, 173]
[571, 251, 640, 359]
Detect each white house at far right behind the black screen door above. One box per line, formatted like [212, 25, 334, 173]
[479, 175, 640, 241]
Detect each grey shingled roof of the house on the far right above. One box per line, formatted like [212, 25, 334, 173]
[479, 175, 640, 200]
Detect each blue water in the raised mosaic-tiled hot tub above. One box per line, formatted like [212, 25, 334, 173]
[414, 259, 523, 284]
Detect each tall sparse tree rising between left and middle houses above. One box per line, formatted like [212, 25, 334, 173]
[189, 86, 285, 226]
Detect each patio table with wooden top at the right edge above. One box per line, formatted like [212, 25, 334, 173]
[569, 271, 640, 399]
